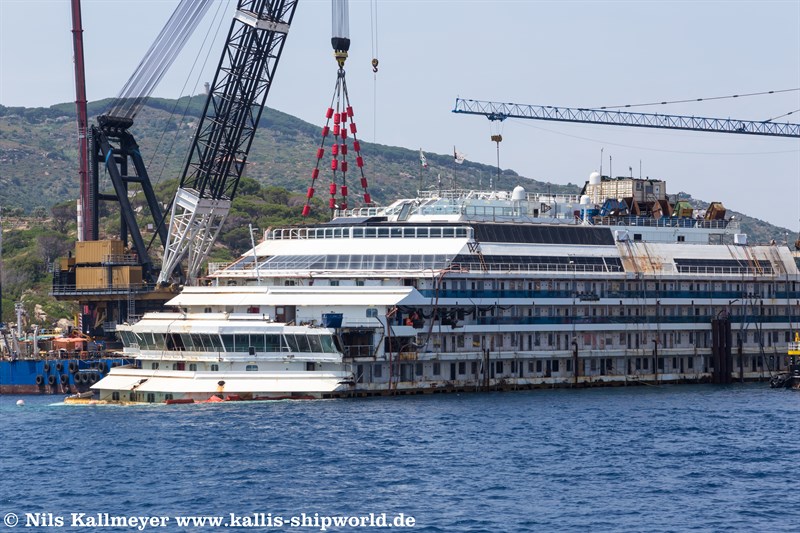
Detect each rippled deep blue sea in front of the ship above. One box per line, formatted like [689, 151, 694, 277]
[0, 385, 800, 532]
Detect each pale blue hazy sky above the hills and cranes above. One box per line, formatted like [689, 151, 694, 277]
[0, 0, 800, 231]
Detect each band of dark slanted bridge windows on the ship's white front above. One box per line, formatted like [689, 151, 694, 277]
[119, 331, 337, 353]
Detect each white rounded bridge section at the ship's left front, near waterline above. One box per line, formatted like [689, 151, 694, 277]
[91, 312, 355, 404]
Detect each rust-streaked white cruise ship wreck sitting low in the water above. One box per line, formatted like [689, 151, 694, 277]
[92, 173, 800, 402]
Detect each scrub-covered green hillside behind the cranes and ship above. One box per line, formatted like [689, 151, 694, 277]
[0, 96, 795, 324]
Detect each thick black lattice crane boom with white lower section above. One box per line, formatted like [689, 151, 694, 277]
[159, 0, 297, 283]
